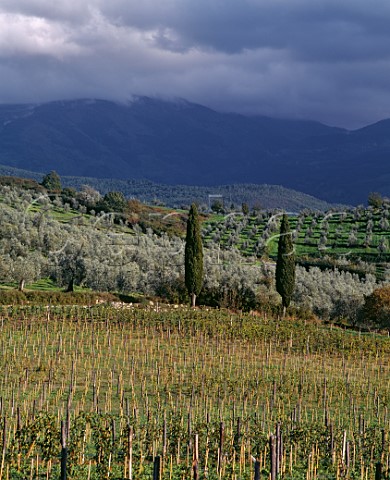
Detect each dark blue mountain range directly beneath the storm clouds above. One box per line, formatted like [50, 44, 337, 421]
[0, 97, 390, 204]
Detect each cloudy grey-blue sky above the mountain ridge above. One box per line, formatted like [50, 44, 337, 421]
[0, 0, 390, 128]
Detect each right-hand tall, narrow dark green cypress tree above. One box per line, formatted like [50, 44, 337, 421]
[275, 215, 295, 316]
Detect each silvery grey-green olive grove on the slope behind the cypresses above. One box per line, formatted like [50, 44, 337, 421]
[0, 186, 389, 322]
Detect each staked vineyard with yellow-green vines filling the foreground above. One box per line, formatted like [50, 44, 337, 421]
[0, 305, 390, 480]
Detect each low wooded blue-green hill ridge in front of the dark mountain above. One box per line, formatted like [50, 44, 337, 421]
[0, 165, 335, 212]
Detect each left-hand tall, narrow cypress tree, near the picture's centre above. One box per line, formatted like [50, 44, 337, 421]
[184, 203, 203, 307]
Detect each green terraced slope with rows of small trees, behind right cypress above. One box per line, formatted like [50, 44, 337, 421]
[203, 203, 390, 266]
